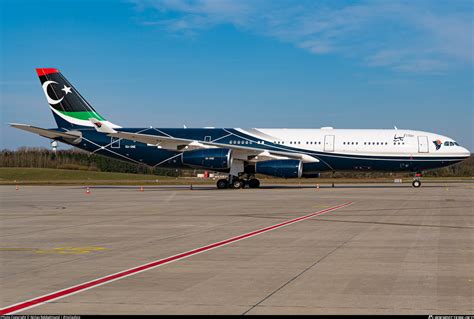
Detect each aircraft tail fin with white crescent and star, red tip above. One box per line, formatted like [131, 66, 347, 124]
[36, 68, 119, 129]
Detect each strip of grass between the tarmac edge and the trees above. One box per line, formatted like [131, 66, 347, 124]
[0, 167, 474, 185]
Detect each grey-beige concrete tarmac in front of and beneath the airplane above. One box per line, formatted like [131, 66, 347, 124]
[0, 183, 474, 315]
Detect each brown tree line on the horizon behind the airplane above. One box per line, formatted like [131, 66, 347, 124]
[0, 147, 474, 178]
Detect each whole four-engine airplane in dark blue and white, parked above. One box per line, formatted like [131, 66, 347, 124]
[10, 68, 470, 189]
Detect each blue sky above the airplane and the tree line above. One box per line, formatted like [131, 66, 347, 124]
[0, 0, 474, 151]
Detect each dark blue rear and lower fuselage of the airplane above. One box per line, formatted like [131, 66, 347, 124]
[54, 128, 464, 176]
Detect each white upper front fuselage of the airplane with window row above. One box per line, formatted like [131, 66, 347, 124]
[237, 128, 470, 158]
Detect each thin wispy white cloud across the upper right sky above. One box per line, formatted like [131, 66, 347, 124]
[134, 0, 474, 72]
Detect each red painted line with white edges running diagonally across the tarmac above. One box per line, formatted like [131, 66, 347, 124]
[0, 202, 352, 315]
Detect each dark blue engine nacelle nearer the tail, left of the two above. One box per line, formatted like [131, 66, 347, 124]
[181, 148, 232, 169]
